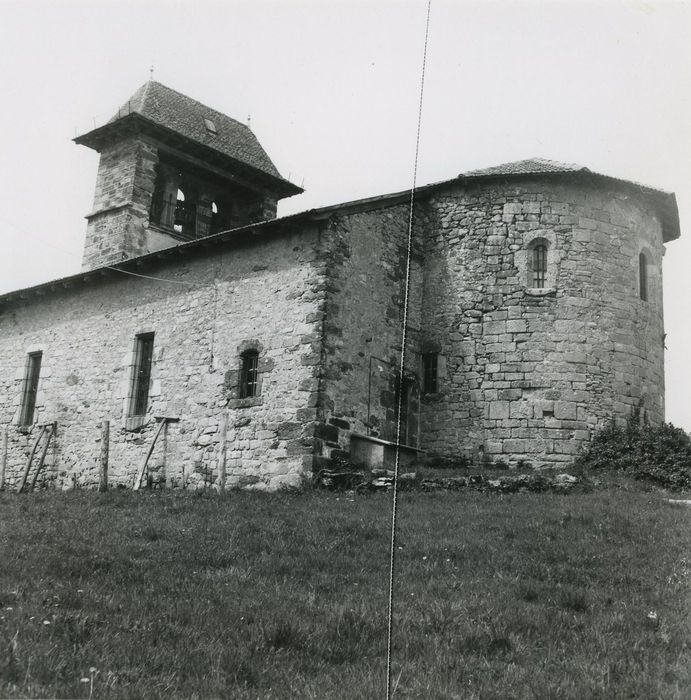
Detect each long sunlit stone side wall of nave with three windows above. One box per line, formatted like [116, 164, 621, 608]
[0, 223, 324, 488]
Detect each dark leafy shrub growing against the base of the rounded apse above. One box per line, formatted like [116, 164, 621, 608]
[576, 415, 691, 489]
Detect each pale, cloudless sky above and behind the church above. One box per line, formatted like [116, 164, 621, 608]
[0, 0, 691, 431]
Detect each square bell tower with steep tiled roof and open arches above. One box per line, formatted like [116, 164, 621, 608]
[75, 80, 302, 270]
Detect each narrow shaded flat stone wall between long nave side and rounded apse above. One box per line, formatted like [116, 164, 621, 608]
[310, 203, 422, 456]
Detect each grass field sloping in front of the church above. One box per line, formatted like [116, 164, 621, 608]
[0, 487, 691, 699]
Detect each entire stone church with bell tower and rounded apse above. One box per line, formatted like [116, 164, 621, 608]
[0, 81, 679, 489]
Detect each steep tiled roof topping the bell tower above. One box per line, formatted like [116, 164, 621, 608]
[108, 80, 281, 177]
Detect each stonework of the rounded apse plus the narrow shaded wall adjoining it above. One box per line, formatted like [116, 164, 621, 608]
[302, 178, 664, 466]
